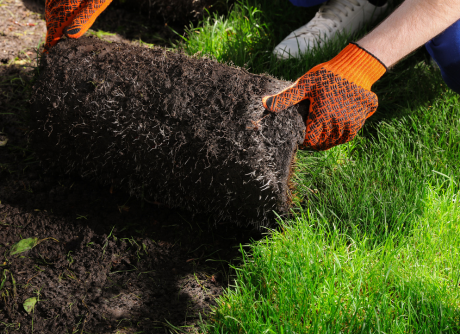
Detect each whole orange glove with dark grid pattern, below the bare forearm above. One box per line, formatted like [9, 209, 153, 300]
[262, 43, 387, 150]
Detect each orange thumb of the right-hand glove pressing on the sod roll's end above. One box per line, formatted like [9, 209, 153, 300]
[262, 72, 313, 112]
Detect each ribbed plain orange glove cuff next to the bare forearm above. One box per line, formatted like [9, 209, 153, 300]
[322, 43, 387, 90]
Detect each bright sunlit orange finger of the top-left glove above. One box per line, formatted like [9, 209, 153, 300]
[64, 0, 112, 38]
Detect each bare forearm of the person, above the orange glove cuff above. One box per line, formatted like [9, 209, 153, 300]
[357, 0, 460, 67]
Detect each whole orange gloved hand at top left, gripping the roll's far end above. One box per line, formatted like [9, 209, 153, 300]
[45, 0, 112, 52]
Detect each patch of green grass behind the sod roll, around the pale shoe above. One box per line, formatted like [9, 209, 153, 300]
[175, 0, 398, 80]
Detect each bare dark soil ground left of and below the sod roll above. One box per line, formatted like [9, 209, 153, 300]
[0, 0, 260, 333]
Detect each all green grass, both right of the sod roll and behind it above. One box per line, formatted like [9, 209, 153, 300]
[175, 0, 460, 333]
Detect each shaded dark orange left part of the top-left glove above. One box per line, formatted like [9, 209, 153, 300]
[45, 0, 82, 52]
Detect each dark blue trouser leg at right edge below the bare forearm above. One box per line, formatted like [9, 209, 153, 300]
[425, 20, 460, 94]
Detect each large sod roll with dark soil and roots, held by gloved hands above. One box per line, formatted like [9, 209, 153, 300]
[30, 37, 305, 226]
